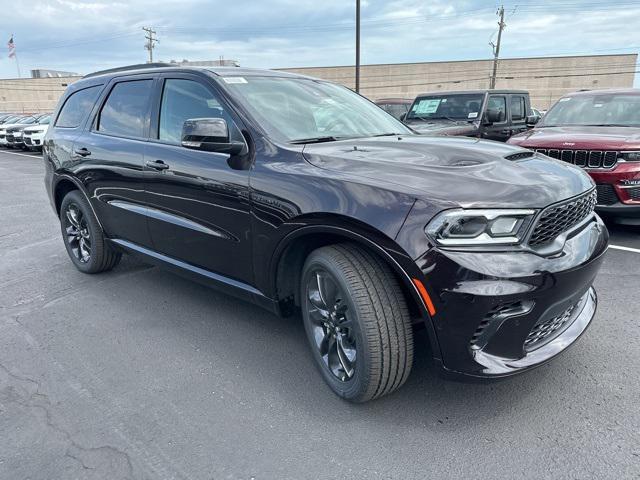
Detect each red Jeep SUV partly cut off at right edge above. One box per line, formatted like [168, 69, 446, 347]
[509, 89, 640, 225]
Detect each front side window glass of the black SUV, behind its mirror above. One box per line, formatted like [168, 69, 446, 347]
[158, 78, 244, 144]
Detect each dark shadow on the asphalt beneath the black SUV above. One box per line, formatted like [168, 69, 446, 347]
[105, 256, 571, 430]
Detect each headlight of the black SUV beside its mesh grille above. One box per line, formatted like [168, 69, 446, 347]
[425, 209, 536, 247]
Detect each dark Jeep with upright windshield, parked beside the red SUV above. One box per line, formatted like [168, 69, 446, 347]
[404, 90, 540, 142]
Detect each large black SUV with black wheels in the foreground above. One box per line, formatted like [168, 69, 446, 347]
[43, 65, 608, 402]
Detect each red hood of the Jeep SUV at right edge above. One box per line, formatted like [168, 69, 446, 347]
[509, 126, 640, 150]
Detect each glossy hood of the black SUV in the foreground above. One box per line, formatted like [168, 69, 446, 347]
[303, 135, 593, 208]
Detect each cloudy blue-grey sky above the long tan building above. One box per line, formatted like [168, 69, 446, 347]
[0, 0, 640, 83]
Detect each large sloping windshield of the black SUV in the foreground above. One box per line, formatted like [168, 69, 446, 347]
[222, 76, 411, 143]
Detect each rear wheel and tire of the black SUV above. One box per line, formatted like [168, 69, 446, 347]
[60, 190, 122, 273]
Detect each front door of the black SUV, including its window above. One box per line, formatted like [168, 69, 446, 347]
[145, 74, 253, 284]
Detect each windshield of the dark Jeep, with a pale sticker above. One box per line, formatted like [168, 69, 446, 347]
[406, 93, 483, 121]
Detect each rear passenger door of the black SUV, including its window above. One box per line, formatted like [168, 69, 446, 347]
[73, 75, 156, 247]
